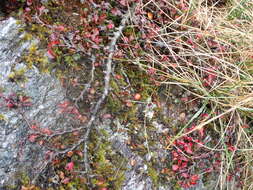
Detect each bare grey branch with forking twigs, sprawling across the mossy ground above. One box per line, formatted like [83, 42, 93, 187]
[26, 8, 131, 183]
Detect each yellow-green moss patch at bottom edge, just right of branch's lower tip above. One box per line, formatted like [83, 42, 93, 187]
[89, 129, 126, 190]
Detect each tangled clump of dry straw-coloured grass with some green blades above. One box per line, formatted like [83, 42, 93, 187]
[123, 0, 253, 189]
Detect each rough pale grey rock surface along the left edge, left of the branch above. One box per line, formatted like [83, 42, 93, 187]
[0, 18, 66, 189]
